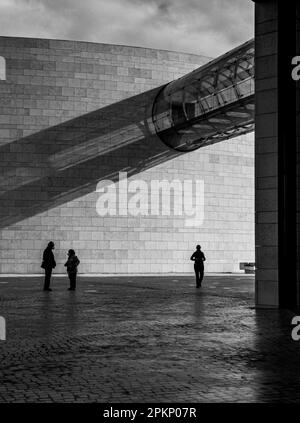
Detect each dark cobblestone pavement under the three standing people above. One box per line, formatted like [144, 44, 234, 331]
[0, 275, 300, 403]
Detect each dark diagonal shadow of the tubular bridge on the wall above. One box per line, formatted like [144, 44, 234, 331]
[0, 88, 181, 228]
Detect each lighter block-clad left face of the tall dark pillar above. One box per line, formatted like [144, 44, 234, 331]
[255, 2, 278, 306]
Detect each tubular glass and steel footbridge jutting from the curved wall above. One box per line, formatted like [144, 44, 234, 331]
[152, 40, 254, 151]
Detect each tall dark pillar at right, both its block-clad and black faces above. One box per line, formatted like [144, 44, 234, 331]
[255, 0, 300, 308]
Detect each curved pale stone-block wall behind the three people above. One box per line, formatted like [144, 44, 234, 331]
[0, 37, 254, 274]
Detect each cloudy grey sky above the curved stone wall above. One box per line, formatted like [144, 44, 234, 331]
[0, 0, 254, 57]
